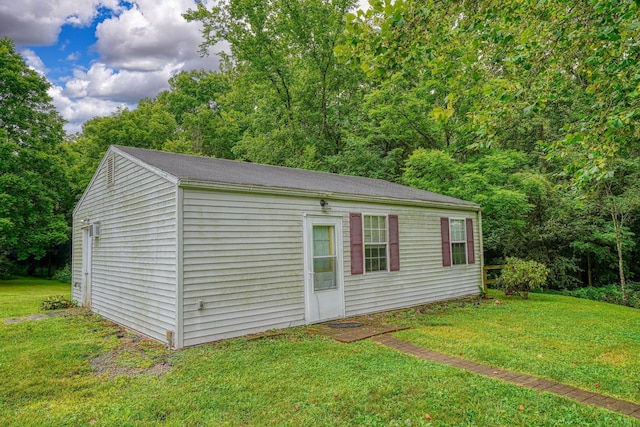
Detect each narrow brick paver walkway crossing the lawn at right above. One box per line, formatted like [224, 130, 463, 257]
[371, 335, 640, 419]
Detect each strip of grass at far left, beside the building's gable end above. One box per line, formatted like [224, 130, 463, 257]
[0, 277, 71, 319]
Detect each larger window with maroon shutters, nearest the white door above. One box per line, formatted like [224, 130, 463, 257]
[349, 213, 400, 274]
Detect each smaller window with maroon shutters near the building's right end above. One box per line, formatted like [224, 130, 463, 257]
[440, 218, 475, 267]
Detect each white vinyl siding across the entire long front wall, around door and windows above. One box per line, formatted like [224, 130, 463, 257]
[183, 189, 481, 346]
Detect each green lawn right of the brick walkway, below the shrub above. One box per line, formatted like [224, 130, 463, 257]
[382, 291, 640, 403]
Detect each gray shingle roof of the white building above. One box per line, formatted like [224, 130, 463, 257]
[115, 146, 477, 208]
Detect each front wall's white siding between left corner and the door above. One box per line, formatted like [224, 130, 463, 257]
[183, 189, 308, 346]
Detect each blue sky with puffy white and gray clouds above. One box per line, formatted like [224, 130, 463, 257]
[0, 0, 224, 134]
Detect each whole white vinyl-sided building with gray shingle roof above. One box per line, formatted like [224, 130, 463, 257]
[73, 146, 482, 348]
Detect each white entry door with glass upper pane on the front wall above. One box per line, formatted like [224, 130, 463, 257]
[304, 216, 344, 323]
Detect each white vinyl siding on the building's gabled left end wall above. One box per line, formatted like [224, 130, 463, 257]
[73, 155, 177, 342]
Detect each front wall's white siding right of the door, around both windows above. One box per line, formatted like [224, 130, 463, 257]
[344, 204, 482, 316]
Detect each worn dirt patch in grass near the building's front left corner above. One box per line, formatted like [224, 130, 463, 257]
[91, 333, 173, 377]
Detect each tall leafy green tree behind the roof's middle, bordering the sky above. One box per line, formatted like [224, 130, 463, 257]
[185, 0, 361, 166]
